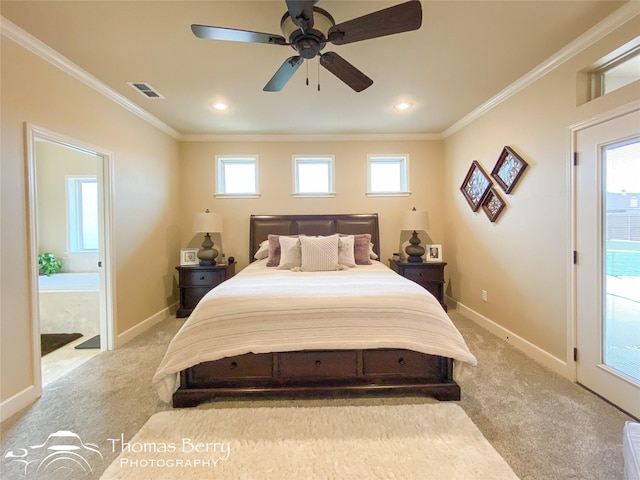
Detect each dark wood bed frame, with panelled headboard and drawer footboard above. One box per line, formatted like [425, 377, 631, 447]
[173, 214, 460, 408]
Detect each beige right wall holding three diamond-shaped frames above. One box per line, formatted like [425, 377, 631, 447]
[443, 18, 640, 371]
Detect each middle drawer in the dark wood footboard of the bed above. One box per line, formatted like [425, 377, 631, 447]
[278, 350, 358, 377]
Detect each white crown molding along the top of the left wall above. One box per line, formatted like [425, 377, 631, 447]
[0, 16, 181, 140]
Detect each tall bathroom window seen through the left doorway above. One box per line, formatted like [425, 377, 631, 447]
[67, 176, 98, 252]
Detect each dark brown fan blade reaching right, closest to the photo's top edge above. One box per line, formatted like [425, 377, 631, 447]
[328, 0, 422, 45]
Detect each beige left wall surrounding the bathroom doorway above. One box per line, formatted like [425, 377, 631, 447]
[0, 37, 180, 402]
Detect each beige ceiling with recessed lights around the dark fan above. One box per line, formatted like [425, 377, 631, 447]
[0, 0, 625, 137]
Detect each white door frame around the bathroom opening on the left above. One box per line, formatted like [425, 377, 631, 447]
[25, 123, 115, 390]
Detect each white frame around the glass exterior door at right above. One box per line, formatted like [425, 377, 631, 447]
[567, 100, 640, 382]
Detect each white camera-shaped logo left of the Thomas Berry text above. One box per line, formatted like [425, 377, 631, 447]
[3, 430, 102, 480]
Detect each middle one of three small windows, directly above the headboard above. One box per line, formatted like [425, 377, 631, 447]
[293, 155, 335, 196]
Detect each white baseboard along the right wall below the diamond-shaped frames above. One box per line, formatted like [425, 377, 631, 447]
[454, 300, 575, 382]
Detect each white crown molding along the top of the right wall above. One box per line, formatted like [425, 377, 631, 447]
[442, 0, 640, 138]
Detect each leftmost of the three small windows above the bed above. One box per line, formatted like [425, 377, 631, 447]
[216, 155, 258, 197]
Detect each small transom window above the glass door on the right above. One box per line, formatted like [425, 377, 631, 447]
[591, 46, 640, 98]
